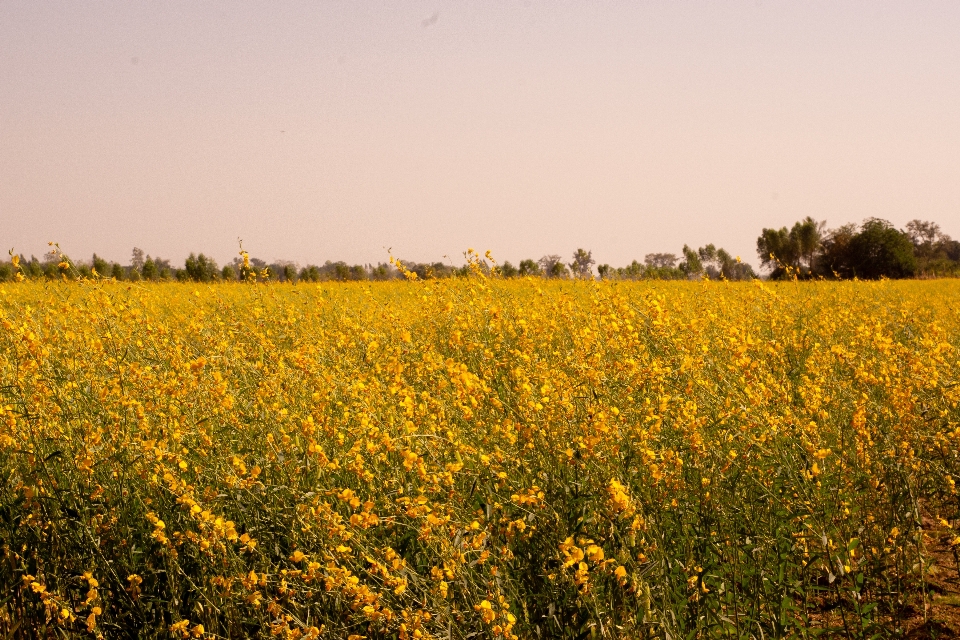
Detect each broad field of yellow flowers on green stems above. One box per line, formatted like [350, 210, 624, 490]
[0, 274, 960, 640]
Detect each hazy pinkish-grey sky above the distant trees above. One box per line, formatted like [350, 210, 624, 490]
[0, 0, 960, 266]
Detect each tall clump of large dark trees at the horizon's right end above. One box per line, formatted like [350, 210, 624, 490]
[757, 217, 960, 279]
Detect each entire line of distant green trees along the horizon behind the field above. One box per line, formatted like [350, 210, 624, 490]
[0, 217, 960, 283]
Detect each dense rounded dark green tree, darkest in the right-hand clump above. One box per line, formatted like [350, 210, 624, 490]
[849, 218, 917, 279]
